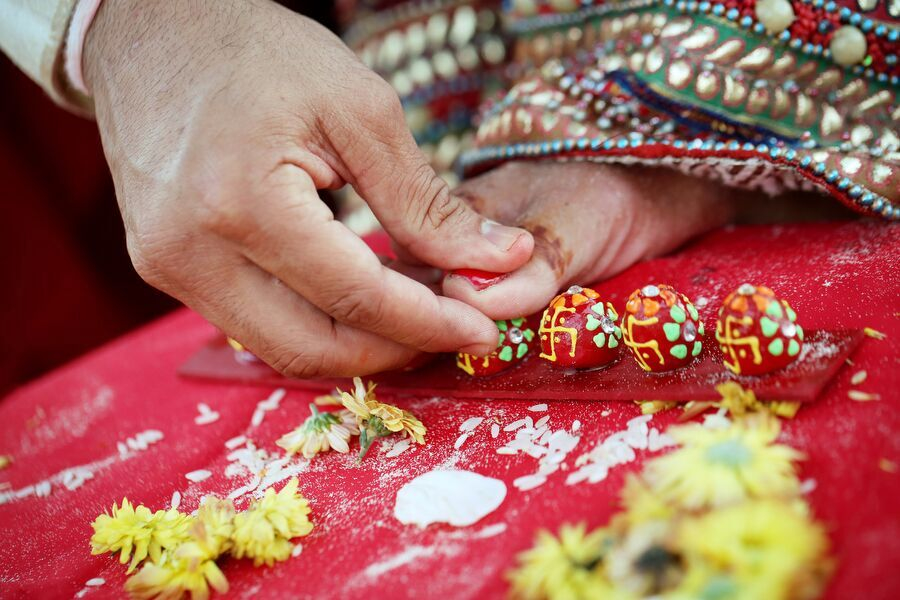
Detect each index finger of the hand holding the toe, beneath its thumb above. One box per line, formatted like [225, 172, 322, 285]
[232, 164, 498, 354]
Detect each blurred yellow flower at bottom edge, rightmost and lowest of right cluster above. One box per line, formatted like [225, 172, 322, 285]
[673, 500, 831, 600]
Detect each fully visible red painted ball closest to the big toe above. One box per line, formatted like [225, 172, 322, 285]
[538, 285, 622, 369]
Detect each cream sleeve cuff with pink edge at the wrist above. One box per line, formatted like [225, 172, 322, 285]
[0, 0, 93, 114]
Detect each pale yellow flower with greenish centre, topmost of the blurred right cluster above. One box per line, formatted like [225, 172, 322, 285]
[644, 416, 802, 510]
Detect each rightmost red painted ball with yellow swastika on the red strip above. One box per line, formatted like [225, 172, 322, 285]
[716, 283, 803, 375]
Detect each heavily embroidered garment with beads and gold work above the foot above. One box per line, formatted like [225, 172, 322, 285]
[346, 0, 900, 219]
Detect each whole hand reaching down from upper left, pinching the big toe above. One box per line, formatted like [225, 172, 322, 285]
[84, 0, 533, 377]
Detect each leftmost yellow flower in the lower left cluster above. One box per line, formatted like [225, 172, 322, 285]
[91, 498, 191, 573]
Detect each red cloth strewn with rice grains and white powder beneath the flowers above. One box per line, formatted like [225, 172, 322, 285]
[0, 222, 900, 600]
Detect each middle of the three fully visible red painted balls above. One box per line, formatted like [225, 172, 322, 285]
[622, 284, 704, 372]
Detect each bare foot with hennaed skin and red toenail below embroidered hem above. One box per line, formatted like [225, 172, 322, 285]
[443, 162, 740, 319]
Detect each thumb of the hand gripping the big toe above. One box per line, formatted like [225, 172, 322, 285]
[332, 84, 534, 273]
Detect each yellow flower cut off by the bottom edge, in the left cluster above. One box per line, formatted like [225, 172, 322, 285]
[125, 536, 228, 600]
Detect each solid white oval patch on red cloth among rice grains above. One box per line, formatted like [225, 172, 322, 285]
[394, 470, 506, 527]
